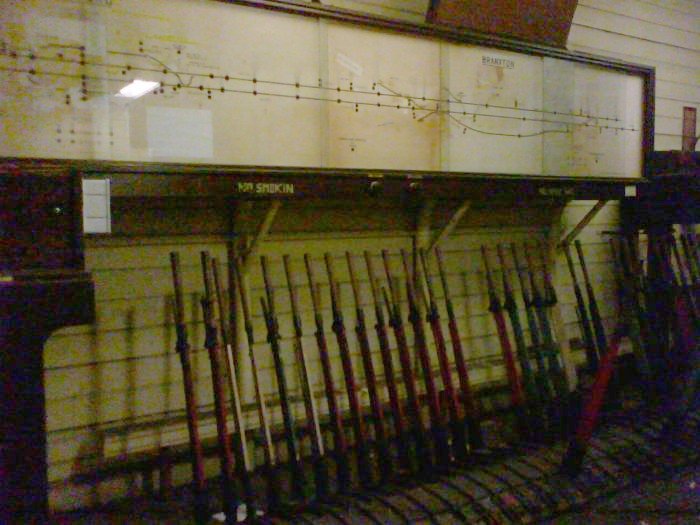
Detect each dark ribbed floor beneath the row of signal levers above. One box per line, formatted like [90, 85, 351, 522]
[53, 411, 700, 525]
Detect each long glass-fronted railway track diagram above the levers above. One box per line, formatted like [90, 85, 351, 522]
[0, 0, 645, 178]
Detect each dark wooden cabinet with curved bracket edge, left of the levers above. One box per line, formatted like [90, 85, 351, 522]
[0, 273, 95, 525]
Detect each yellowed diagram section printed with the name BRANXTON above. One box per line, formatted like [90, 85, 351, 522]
[443, 46, 545, 175]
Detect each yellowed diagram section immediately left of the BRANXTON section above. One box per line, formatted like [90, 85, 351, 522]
[328, 24, 440, 170]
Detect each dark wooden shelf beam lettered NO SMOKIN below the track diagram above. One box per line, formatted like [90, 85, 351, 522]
[0, 158, 644, 202]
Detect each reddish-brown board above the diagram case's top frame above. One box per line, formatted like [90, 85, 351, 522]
[427, 0, 577, 48]
